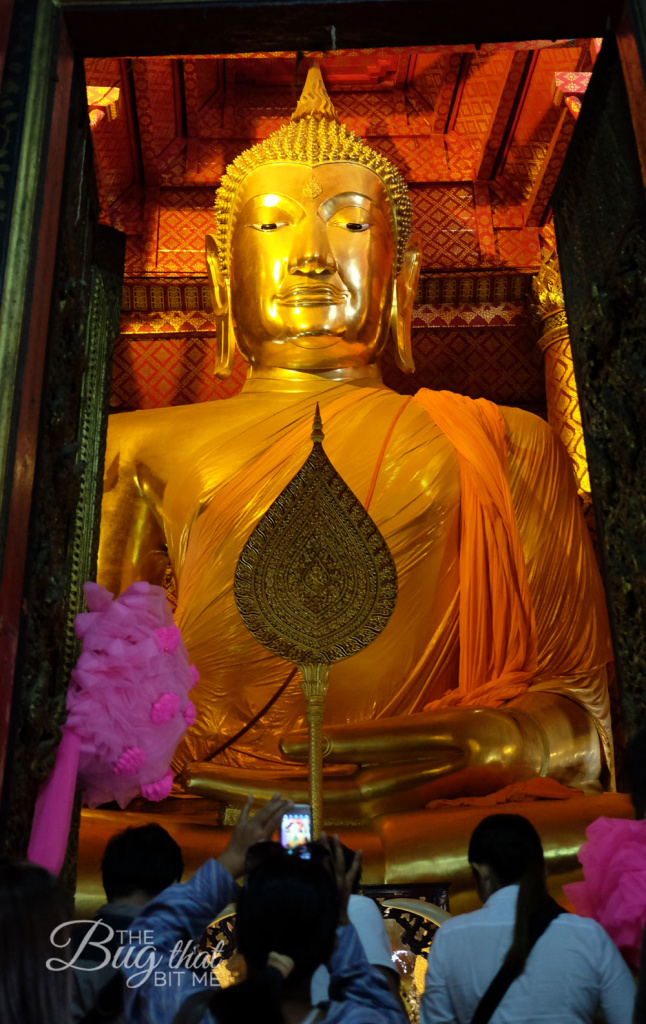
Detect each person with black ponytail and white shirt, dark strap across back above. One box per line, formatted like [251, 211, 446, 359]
[420, 814, 635, 1024]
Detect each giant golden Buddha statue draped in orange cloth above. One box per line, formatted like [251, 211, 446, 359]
[99, 69, 612, 821]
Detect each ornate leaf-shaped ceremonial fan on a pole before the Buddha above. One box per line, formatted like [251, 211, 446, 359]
[233, 404, 397, 836]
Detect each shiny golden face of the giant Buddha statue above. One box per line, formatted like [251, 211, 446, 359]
[230, 163, 395, 371]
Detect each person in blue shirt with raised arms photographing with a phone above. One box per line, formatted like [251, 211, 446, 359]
[123, 796, 405, 1024]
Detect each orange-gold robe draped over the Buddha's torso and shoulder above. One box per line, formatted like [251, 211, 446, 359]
[160, 382, 611, 774]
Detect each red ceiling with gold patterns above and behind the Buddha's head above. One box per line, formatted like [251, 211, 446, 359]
[85, 39, 599, 278]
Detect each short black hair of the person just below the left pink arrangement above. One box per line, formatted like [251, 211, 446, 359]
[101, 822, 184, 902]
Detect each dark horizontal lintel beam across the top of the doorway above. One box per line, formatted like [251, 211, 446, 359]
[59, 0, 621, 56]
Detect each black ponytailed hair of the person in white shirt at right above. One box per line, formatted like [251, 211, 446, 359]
[469, 814, 554, 977]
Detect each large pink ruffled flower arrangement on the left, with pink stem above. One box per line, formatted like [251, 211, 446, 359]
[29, 583, 199, 873]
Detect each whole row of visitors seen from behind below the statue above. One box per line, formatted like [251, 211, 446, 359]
[0, 778, 643, 1024]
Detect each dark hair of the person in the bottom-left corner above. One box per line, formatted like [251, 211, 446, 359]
[0, 861, 71, 1024]
